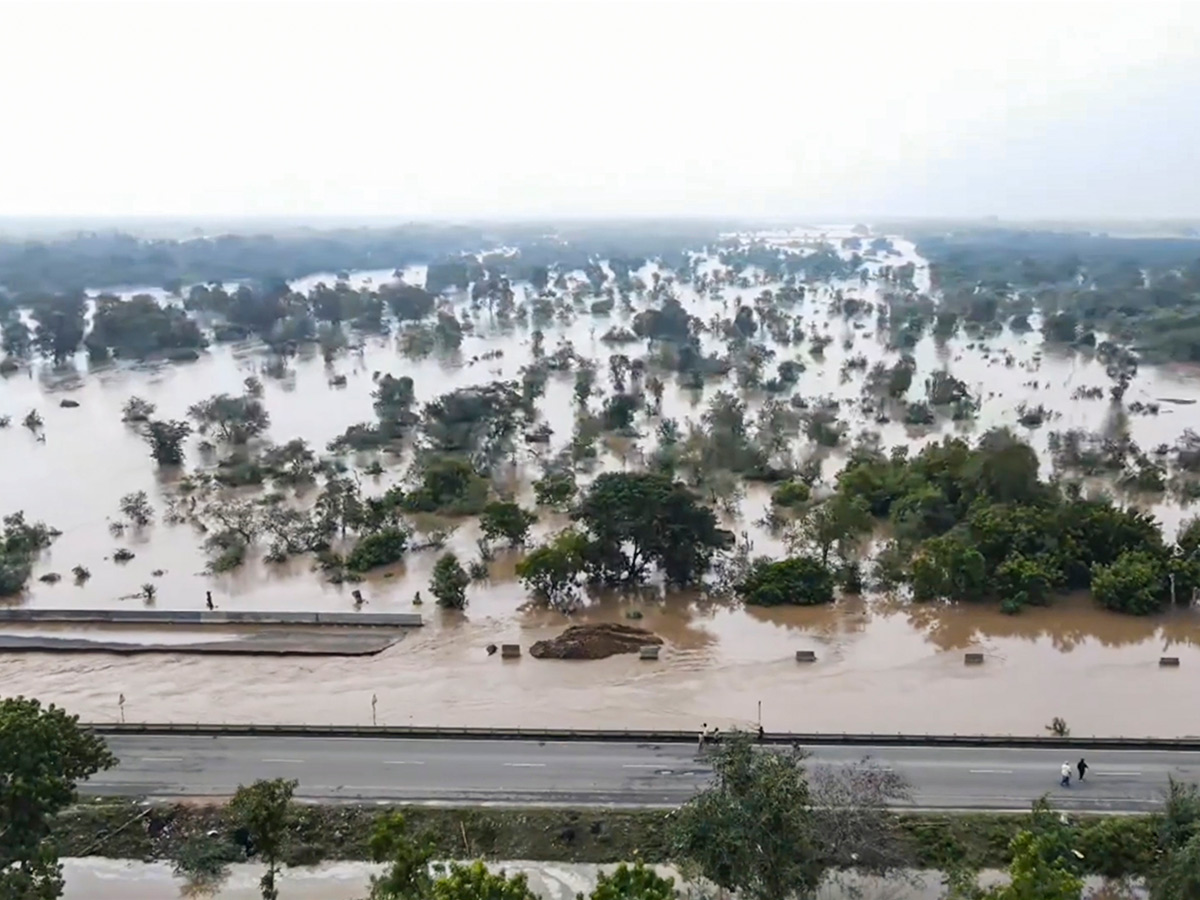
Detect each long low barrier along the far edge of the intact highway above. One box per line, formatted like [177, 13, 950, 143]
[88, 722, 1200, 751]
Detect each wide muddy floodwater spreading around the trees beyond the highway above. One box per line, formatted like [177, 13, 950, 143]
[0, 229, 1200, 734]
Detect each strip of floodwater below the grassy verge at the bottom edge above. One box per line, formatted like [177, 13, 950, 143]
[64, 858, 1145, 900]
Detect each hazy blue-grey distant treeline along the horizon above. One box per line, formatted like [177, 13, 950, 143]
[0, 218, 1200, 296]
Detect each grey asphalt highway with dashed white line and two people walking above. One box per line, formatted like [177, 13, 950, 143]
[83, 736, 1200, 812]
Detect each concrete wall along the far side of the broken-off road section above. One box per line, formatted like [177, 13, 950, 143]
[0, 608, 422, 628]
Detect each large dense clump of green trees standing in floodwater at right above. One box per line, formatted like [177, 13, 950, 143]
[827, 430, 1200, 614]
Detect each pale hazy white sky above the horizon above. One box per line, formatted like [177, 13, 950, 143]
[0, 0, 1200, 217]
